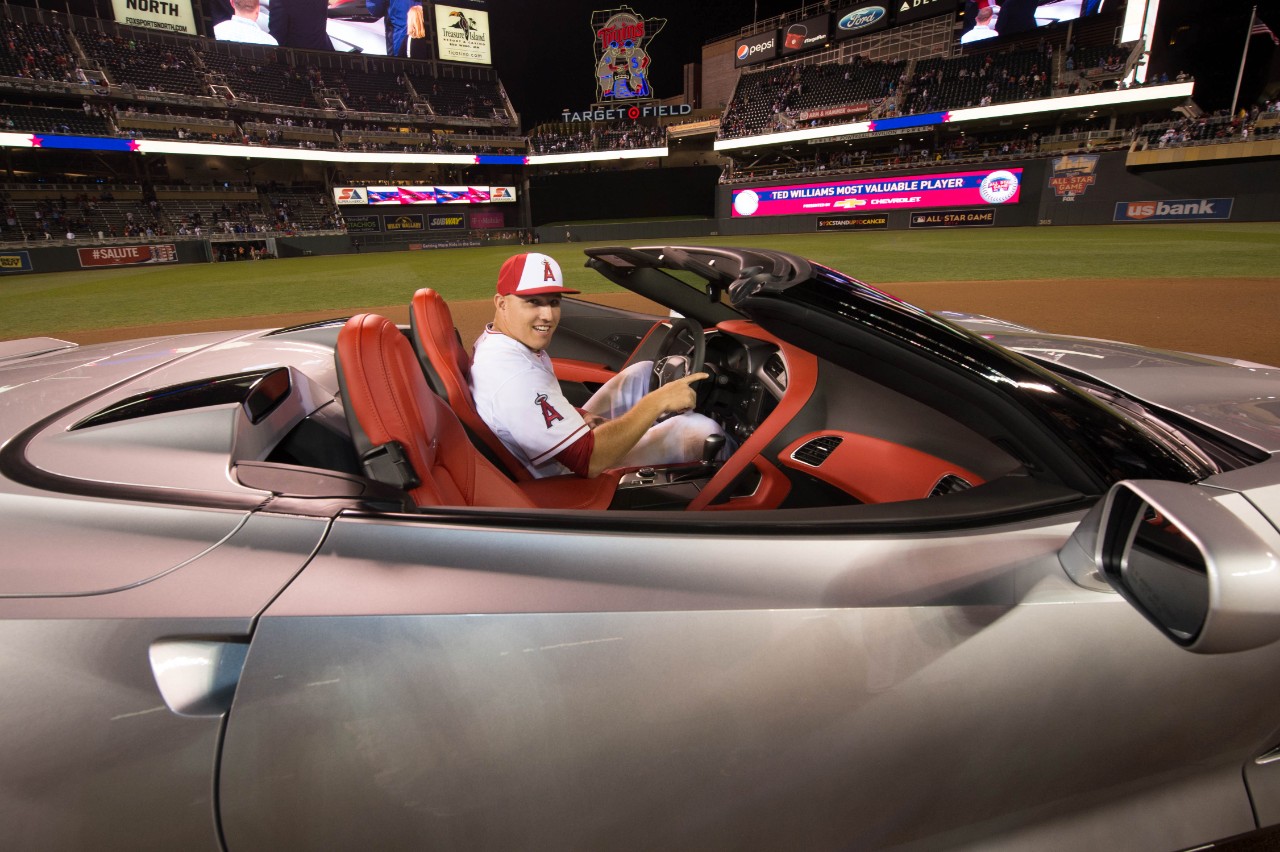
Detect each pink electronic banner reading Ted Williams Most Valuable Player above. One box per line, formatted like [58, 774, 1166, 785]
[733, 169, 1023, 219]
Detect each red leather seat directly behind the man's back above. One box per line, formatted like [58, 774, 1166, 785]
[408, 288, 622, 509]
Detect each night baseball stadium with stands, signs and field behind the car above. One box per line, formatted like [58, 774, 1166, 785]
[0, 0, 1280, 363]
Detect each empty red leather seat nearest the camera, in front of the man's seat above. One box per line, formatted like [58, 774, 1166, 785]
[335, 313, 617, 509]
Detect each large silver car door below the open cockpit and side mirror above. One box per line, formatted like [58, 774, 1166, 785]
[221, 506, 1280, 851]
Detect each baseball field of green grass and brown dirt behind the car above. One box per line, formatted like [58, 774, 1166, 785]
[0, 223, 1280, 365]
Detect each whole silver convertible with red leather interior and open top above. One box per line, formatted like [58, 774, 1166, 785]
[0, 247, 1280, 852]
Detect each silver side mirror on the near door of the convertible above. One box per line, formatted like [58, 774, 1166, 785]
[1094, 480, 1280, 654]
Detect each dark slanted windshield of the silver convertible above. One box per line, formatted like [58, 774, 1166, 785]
[736, 264, 1216, 493]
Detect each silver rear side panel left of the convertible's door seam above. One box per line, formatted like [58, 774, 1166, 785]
[0, 511, 326, 852]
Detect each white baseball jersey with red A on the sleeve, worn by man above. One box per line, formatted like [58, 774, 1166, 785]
[471, 327, 588, 477]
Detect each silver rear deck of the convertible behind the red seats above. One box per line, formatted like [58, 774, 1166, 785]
[0, 324, 338, 500]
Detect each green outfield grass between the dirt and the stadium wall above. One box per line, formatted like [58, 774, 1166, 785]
[0, 223, 1280, 339]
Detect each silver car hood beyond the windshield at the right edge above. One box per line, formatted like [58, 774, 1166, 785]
[938, 311, 1280, 453]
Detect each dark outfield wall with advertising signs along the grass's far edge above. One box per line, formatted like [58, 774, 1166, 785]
[0, 151, 1280, 274]
